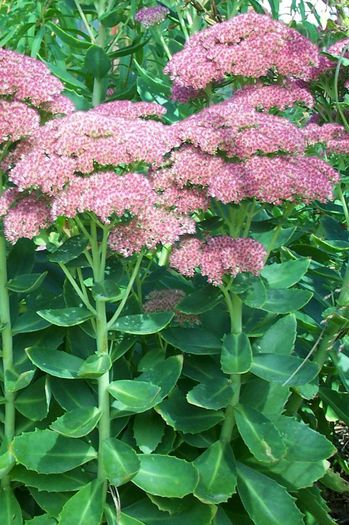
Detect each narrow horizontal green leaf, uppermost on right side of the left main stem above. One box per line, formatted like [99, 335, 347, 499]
[109, 312, 174, 335]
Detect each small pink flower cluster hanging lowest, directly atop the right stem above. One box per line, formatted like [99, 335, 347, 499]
[170, 236, 266, 286]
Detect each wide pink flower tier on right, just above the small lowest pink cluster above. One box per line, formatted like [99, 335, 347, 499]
[152, 146, 338, 211]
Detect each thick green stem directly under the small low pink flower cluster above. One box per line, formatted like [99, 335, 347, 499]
[220, 286, 242, 444]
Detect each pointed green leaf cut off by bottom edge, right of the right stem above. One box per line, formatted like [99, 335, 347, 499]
[237, 463, 304, 525]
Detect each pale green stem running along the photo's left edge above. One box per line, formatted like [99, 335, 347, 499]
[0, 234, 15, 488]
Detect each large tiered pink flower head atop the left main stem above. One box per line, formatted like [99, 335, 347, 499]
[4, 102, 195, 248]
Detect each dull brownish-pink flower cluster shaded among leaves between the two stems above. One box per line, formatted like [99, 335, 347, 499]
[143, 288, 200, 326]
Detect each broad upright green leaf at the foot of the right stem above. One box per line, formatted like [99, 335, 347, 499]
[194, 441, 237, 504]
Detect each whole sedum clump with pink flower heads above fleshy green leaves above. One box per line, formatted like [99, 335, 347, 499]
[0, 5, 346, 525]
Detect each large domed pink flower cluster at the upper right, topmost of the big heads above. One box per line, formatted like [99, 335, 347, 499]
[165, 12, 319, 96]
